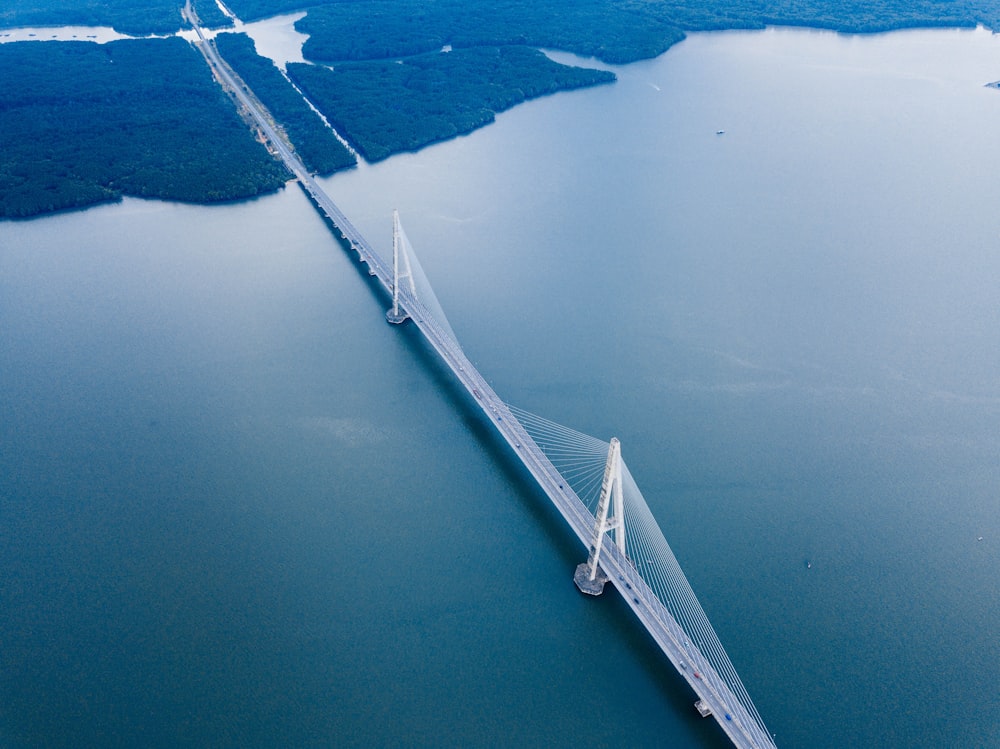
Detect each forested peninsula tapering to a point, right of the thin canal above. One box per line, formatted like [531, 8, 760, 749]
[288, 47, 615, 161]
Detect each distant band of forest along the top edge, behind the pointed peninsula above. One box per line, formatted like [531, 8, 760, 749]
[219, 0, 1000, 63]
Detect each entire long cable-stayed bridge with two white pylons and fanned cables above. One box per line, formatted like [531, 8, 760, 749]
[185, 12, 775, 749]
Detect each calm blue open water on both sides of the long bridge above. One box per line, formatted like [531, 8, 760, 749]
[0, 24, 1000, 747]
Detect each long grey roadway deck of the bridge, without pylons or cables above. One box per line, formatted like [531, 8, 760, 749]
[187, 14, 775, 749]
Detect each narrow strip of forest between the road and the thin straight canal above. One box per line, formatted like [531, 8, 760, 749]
[215, 34, 357, 175]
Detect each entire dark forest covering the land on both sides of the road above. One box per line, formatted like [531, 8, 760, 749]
[0, 0, 1000, 218]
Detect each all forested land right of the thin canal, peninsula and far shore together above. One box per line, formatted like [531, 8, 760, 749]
[223, 0, 1000, 160]
